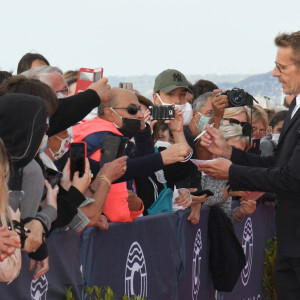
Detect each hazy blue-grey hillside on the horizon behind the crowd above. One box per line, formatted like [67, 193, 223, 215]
[109, 72, 282, 104]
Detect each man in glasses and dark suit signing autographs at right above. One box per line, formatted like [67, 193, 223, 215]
[198, 31, 300, 300]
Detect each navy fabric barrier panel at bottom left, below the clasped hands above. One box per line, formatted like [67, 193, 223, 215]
[0, 231, 83, 300]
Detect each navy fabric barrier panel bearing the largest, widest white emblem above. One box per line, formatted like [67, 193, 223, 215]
[81, 213, 181, 299]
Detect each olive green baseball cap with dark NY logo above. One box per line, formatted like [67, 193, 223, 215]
[154, 69, 192, 93]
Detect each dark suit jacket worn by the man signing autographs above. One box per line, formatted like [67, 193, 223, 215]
[229, 99, 300, 257]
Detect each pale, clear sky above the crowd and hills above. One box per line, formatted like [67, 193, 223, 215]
[0, 0, 300, 77]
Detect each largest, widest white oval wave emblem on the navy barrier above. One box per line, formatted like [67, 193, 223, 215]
[125, 242, 147, 298]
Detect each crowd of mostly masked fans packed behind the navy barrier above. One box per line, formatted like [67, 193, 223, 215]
[0, 53, 288, 282]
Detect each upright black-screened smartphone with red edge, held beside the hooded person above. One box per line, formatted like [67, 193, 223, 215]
[70, 142, 86, 180]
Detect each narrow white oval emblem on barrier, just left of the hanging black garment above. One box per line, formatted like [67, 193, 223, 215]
[192, 229, 202, 300]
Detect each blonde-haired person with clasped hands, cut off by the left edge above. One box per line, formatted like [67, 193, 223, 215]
[0, 138, 22, 283]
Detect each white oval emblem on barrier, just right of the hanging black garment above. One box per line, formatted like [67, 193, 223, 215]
[241, 218, 253, 286]
